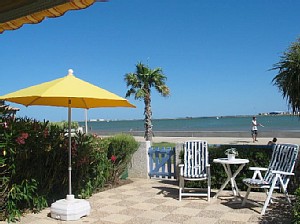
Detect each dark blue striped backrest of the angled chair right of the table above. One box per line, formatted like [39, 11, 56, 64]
[264, 144, 299, 185]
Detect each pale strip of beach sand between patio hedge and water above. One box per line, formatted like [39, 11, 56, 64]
[134, 136, 300, 145]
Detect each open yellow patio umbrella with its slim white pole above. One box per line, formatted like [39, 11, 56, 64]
[0, 69, 135, 220]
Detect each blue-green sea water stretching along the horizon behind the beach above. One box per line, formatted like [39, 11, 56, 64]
[79, 115, 300, 137]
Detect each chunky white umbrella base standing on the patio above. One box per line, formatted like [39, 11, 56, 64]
[50, 195, 91, 221]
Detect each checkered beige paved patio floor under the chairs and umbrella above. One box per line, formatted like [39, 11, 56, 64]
[0, 179, 291, 224]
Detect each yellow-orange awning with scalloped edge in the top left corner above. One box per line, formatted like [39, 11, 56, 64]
[0, 0, 101, 33]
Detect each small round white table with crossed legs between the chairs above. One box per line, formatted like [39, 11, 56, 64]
[213, 158, 249, 200]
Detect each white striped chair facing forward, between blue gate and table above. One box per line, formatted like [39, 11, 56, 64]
[179, 140, 211, 201]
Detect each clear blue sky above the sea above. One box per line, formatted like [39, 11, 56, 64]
[0, 0, 300, 121]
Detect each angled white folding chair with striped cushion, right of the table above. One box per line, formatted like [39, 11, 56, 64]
[242, 144, 299, 215]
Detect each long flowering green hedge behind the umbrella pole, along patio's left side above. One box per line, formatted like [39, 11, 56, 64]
[0, 114, 138, 222]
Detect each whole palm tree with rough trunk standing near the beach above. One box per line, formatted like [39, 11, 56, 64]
[124, 62, 170, 141]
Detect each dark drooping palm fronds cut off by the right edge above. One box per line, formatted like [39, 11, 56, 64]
[271, 39, 300, 113]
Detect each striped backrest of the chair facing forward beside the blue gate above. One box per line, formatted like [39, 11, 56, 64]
[183, 140, 208, 178]
